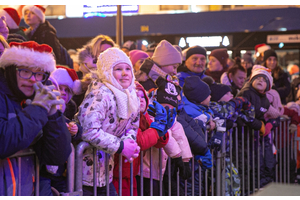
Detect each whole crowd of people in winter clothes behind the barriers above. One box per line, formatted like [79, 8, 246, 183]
[0, 5, 300, 196]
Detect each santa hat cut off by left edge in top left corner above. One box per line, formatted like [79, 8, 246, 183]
[0, 8, 21, 29]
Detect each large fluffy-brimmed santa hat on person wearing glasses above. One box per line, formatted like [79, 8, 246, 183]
[0, 41, 56, 73]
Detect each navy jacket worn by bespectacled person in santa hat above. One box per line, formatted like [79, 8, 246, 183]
[0, 69, 71, 196]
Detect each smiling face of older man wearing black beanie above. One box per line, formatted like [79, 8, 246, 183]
[185, 54, 206, 73]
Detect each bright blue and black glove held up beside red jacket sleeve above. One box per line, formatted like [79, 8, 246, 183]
[147, 101, 168, 137]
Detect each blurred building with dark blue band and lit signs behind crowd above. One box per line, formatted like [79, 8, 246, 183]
[0, 5, 300, 67]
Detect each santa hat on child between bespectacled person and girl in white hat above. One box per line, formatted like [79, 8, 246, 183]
[49, 66, 81, 100]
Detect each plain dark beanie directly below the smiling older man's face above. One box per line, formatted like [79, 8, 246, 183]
[182, 76, 210, 104]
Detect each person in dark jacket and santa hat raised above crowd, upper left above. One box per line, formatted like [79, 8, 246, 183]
[22, 5, 65, 65]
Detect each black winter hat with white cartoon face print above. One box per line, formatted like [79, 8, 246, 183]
[155, 76, 181, 109]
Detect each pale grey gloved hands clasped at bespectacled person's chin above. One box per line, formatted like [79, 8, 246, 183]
[31, 82, 64, 113]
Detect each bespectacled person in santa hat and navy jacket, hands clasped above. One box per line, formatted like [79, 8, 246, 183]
[0, 42, 71, 196]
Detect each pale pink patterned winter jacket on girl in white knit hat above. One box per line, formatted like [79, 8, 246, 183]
[75, 81, 139, 187]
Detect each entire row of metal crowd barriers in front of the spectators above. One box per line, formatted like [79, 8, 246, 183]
[5, 119, 300, 196]
